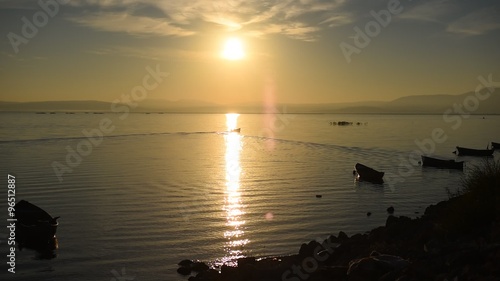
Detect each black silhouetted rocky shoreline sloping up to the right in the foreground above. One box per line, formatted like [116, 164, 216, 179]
[181, 195, 500, 281]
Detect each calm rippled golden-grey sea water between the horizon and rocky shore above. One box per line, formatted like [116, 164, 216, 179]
[0, 112, 500, 281]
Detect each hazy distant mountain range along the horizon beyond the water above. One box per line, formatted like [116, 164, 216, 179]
[0, 88, 500, 114]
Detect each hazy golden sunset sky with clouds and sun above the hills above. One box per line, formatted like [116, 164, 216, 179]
[0, 0, 500, 104]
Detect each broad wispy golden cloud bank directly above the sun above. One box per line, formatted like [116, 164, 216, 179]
[62, 0, 349, 41]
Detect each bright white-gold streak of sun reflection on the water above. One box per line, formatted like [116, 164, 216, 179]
[222, 113, 249, 265]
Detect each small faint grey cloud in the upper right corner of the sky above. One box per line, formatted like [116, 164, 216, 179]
[446, 7, 500, 35]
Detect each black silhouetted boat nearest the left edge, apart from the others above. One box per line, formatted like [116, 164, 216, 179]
[14, 200, 59, 245]
